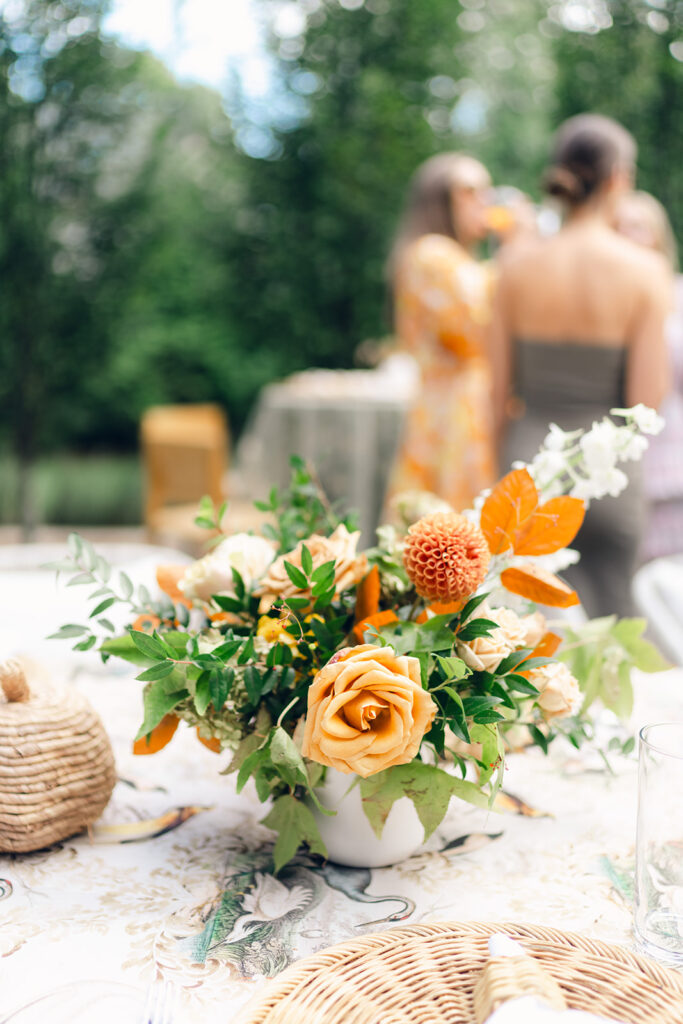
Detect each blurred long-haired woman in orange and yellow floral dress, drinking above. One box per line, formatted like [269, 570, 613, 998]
[389, 153, 496, 509]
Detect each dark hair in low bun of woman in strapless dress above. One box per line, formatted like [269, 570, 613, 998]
[544, 114, 638, 207]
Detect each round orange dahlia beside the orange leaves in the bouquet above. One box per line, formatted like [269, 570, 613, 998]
[403, 512, 490, 601]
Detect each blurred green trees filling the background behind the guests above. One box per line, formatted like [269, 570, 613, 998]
[0, 0, 683, 520]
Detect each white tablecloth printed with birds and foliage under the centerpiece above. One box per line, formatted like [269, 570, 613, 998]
[0, 552, 683, 1024]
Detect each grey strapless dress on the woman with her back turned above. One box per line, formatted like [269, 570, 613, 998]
[504, 340, 644, 616]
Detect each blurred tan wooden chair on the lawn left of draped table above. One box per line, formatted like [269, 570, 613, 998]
[140, 404, 229, 554]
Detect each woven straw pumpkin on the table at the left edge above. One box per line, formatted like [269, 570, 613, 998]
[0, 660, 116, 853]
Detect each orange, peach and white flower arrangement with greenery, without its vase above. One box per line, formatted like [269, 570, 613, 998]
[56, 407, 665, 869]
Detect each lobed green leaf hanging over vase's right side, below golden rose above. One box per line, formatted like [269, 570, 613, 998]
[360, 761, 488, 839]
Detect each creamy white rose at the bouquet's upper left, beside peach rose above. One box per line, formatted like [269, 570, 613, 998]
[183, 534, 275, 601]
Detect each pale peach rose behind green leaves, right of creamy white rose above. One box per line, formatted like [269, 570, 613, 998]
[256, 523, 368, 611]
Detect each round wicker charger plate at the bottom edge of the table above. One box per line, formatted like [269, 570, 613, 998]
[236, 922, 683, 1024]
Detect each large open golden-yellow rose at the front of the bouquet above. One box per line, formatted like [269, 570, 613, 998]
[301, 644, 436, 778]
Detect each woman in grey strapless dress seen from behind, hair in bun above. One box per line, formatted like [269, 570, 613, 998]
[492, 115, 670, 617]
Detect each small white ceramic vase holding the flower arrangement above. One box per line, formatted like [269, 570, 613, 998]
[311, 768, 424, 867]
